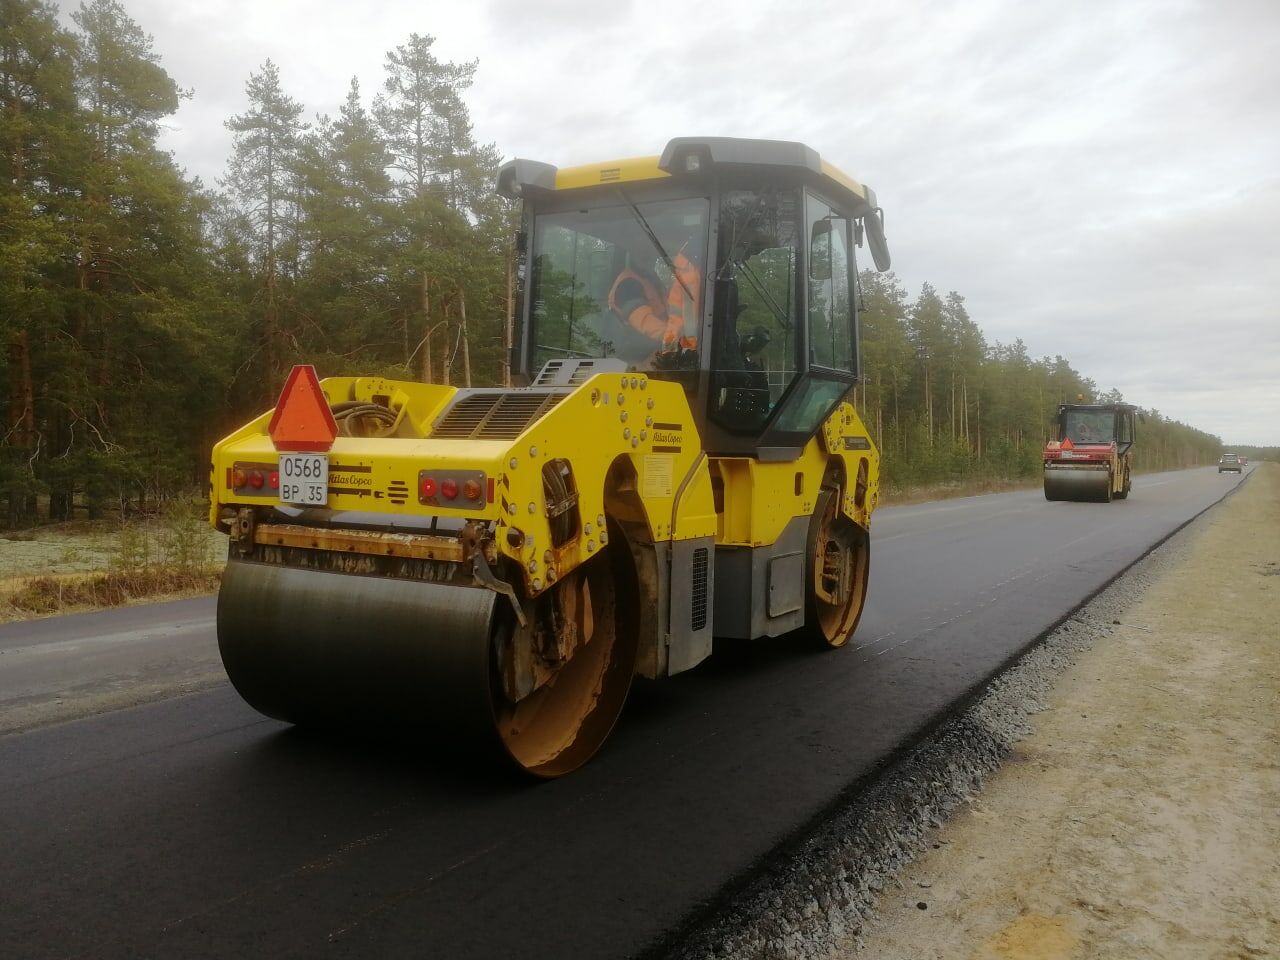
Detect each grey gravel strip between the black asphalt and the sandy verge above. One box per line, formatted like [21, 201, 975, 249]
[655, 470, 1254, 960]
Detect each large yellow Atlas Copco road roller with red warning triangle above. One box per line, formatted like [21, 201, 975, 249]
[210, 138, 890, 777]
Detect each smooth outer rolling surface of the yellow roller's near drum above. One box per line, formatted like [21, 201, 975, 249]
[218, 559, 496, 746]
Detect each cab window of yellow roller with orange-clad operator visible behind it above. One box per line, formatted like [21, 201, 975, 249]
[529, 193, 710, 370]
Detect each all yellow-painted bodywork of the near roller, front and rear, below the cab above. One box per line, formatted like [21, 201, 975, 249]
[210, 374, 879, 585]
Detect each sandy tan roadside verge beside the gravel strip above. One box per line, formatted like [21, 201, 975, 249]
[835, 463, 1280, 960]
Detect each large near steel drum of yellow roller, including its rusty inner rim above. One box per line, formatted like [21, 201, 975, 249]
[218, 542, 645, 776]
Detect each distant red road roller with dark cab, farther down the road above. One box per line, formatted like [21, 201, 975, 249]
[1044, 403, 1137, 503]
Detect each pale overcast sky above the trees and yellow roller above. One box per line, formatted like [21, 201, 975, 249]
[55, 0, 1280, 444]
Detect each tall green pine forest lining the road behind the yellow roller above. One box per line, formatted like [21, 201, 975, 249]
[0, 0, 1220, 526]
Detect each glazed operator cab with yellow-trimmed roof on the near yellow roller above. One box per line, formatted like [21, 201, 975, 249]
[498, 138, 890, 460]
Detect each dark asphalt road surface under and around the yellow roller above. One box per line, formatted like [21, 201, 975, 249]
[0, 467, 1248, 960]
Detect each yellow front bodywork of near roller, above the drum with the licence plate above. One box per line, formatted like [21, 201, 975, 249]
[210, 374, 717, 595]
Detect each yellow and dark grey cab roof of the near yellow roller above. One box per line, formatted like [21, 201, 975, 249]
[498, 137, 877, 214]
